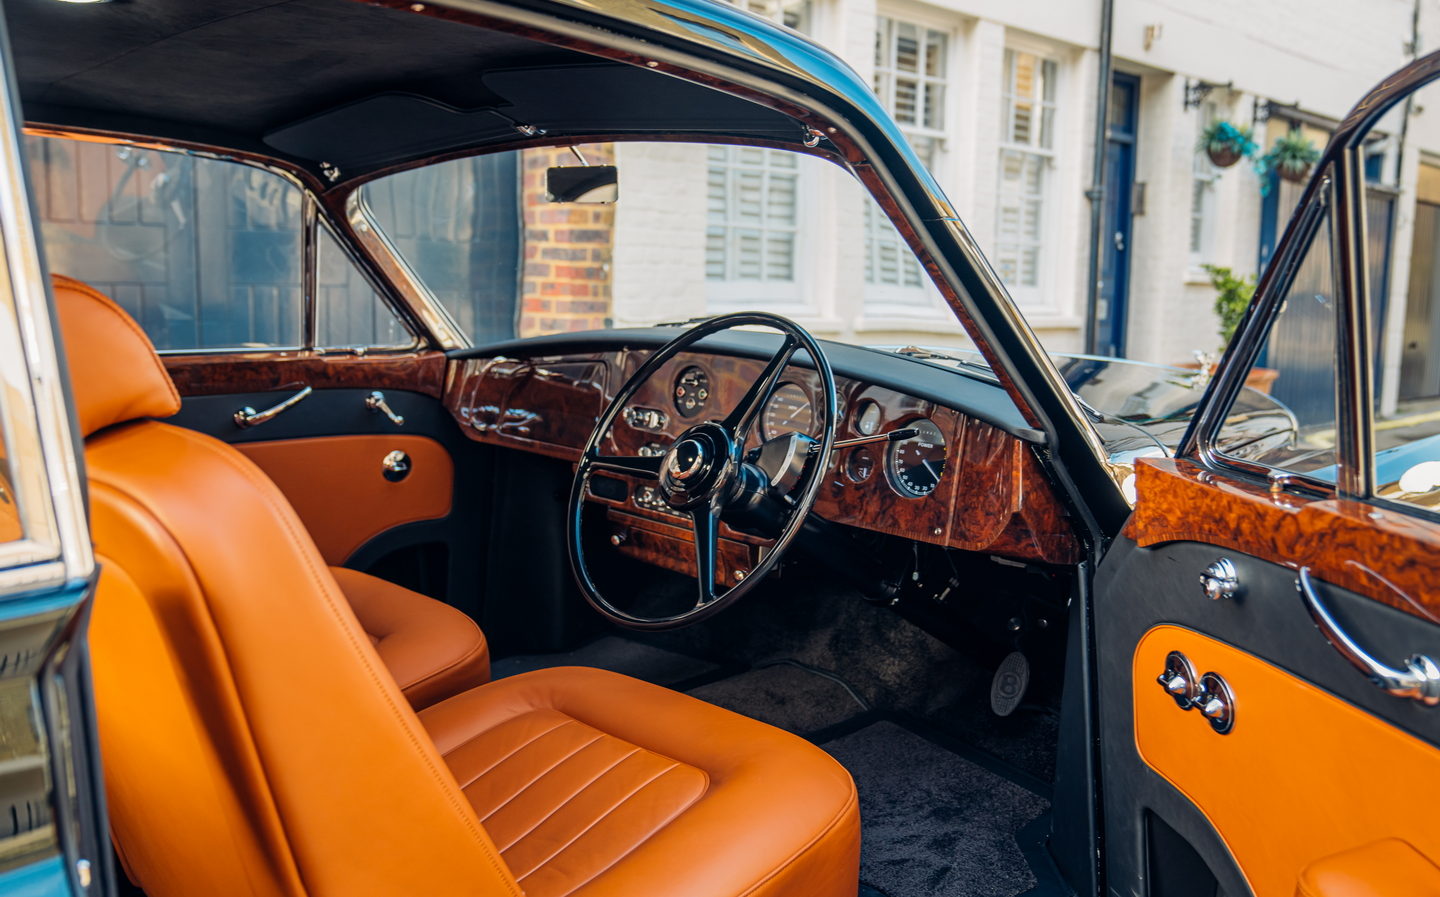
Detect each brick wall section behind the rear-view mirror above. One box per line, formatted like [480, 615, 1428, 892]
[520, 144, 615, 337]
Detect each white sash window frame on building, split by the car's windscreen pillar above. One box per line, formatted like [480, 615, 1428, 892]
[861, 7, 962, 315]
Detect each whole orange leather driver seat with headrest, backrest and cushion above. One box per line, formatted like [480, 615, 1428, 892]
[58, 277, 860, 897]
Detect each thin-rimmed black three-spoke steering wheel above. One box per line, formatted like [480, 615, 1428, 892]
[566, 311, 838, 629]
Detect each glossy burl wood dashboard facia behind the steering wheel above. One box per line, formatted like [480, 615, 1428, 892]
[445, 350, 1081, 564]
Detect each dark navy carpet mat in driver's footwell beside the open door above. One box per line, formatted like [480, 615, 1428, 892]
[822, 723, 1050, 897]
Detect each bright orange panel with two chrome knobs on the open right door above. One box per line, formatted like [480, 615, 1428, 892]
[1133, 626, 1440, 897]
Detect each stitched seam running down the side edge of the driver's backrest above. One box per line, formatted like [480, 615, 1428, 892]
[164, 423, 524, 897]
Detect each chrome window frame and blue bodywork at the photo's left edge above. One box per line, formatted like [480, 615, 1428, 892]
[0, 15, 112, 897]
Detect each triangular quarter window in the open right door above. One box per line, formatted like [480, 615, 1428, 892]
[1215, 203, 1339, 482]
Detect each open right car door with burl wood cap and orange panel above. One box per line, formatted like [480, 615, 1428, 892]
[1094, 56, 1440, 897]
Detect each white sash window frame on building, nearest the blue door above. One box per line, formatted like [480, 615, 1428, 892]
[994, 43, 1068, 313]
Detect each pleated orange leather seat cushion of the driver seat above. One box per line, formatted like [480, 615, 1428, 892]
[420, 667, 860, 897]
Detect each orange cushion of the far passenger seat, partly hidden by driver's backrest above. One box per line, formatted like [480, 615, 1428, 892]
[330, 567, 490, 708]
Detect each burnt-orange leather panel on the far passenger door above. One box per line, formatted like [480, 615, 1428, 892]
[235, 435, 455, 564]
